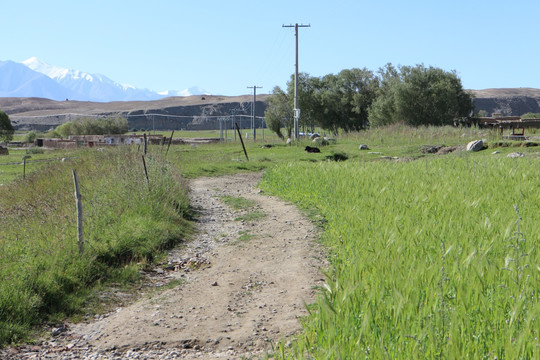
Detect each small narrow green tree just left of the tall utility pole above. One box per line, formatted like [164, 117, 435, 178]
[264, 86, 294, 140]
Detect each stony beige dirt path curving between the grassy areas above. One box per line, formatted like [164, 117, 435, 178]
[7, 174, 323, 359]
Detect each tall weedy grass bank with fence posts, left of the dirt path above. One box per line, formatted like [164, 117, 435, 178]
[0, 147, 189, 344]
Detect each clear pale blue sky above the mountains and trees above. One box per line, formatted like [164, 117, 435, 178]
[4, 0, 540, 95]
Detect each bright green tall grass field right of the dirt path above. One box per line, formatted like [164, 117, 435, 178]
[262, 154, 540, 359]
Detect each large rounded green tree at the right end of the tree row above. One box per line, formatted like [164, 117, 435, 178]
[369, 64, 473, 126]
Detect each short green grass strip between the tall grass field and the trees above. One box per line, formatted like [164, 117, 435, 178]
[168, 125, 540, 178]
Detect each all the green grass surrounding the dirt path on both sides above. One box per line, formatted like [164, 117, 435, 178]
[0, 125, 540, 359]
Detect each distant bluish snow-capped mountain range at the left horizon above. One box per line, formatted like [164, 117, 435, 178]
[0, 57, 207, 102]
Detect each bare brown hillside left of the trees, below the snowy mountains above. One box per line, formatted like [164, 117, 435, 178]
[0, 94, 268, 131]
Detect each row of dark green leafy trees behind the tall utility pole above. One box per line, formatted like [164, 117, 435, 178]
[265, 63, 473, 139]
